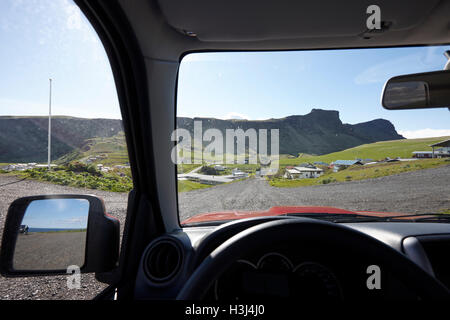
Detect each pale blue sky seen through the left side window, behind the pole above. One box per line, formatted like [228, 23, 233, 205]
[0, 0, 121, 119]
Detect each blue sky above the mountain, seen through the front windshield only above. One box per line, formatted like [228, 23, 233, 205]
[178, 46, 450, 137]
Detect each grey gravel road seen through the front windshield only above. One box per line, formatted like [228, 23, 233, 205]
[178, 166, 450, 221]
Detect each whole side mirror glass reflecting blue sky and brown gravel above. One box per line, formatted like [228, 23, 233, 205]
[13, 199, 89, 270]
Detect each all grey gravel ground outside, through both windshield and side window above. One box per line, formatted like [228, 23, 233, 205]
[0, 166, 450, 299]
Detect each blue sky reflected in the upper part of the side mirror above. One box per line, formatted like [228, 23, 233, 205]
[22, 199, 89, 229]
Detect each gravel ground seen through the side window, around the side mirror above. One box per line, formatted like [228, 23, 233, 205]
[0, 175, 128, 300]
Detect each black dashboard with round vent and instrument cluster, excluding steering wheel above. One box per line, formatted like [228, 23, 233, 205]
[135, 219, 450, 301]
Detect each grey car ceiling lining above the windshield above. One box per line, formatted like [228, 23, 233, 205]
[120, 0, 450, 60]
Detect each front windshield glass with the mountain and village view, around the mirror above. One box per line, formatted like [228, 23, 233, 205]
[176, 46, 450, 225]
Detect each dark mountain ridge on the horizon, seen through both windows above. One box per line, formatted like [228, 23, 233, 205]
[0, 109, 404, 162]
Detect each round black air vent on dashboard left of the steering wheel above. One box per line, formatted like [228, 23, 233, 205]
[144, 239, 183, 284]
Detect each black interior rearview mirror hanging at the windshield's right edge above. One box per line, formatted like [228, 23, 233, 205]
[381, 70, 450, 110]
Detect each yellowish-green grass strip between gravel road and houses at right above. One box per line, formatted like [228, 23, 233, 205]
[269, 158, 450, 187]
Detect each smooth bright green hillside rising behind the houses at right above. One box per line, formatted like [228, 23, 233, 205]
[280, 137, 450, 167]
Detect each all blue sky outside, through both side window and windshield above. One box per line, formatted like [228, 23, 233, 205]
[0, 0, 450, 137]
